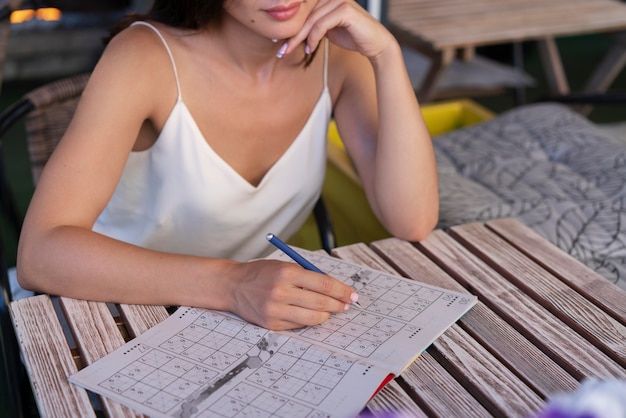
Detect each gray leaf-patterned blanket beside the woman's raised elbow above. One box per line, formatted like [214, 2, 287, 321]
[434, 104, 626, 289]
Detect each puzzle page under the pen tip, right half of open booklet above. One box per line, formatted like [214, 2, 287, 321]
[269, 249, 478, 376]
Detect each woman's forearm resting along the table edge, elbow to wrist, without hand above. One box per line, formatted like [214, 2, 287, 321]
[18, 226, 237, 309]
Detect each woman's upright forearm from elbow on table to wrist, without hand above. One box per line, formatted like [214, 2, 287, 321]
[372, 43, 439, 240]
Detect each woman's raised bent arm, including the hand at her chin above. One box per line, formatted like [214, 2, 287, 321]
[280, 0, 439, 241]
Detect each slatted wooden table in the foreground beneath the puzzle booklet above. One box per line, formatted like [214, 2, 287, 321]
[11, 220, 626, 417]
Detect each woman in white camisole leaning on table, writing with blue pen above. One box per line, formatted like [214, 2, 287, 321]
[18, 0, 438, 329]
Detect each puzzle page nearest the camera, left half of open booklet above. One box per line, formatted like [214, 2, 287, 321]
[69, 308, 388, 418]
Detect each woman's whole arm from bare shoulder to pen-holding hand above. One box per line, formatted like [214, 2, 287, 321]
[17, 27, 353, 329]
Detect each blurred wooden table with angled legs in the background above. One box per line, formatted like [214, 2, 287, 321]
[387, 0, 626, 102]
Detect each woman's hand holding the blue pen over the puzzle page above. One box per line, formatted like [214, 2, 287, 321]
[228, 260, 357, 330]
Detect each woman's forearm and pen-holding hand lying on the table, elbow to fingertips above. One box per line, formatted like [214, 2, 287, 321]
[18, 226, 356, 330]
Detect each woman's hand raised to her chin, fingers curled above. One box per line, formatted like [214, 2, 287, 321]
[282, 0, 396, 60]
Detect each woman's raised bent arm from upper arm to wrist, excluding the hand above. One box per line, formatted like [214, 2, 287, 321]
[335, 41, 439, 241]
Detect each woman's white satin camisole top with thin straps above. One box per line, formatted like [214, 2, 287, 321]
[93, 22, 332, 261]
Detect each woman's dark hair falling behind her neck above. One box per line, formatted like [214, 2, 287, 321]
[104, 0, 317, 66]
